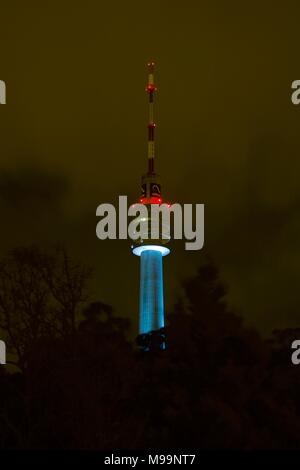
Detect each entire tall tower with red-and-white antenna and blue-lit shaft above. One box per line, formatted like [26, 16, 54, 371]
[132, 62, 170, 351]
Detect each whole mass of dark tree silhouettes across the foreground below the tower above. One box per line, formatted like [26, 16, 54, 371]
[0, 252, 300, 450]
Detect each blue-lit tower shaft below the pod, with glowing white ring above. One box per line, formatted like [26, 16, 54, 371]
[133, 245, 170, 351]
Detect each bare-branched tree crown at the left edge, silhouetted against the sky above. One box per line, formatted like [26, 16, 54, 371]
[0, 246, 91, 370]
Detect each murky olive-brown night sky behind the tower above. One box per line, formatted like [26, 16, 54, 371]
[0, 0, 300, 333]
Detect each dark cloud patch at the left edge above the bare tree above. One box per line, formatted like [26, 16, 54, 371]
[0, 166, 68, 253]
